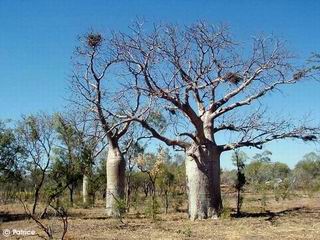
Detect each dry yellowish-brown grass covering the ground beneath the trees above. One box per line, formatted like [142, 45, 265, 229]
[0, 196, 320, 240]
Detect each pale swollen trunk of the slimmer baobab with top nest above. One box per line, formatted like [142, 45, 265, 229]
[106, 146, 126, 217]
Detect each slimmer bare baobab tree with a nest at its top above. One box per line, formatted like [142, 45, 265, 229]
[70, 32, 147, 216]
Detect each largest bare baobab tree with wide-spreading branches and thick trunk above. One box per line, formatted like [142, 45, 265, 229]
[112, 23, 319, 220]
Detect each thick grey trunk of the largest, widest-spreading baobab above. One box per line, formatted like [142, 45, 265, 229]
[186, 147, 222, 220]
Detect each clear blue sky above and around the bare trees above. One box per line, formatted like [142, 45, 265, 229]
[0, 0, 320, 167]
